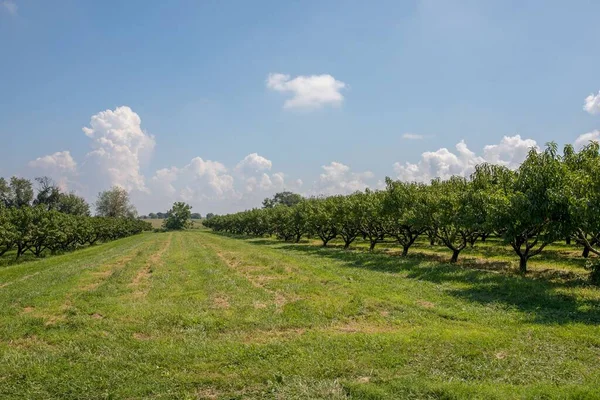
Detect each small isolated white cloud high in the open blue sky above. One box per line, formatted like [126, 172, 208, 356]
[267, 73, 347, 109]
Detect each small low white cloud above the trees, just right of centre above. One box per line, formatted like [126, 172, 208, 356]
[309, 161, 373, 195]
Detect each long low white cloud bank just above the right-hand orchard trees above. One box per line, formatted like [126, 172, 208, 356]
[394, 135, 537, 182]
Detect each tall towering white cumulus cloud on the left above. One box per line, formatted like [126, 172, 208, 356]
[83, 106, 155, 191]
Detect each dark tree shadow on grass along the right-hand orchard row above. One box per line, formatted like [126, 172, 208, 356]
[211, 233, 600, 325]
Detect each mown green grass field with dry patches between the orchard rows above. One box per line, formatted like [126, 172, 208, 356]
[0, 230, 600, 399]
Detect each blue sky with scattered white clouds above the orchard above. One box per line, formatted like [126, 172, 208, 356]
[0, 0, 600, 214]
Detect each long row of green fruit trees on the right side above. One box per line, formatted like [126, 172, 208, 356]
[204, 143, 600, 282]
